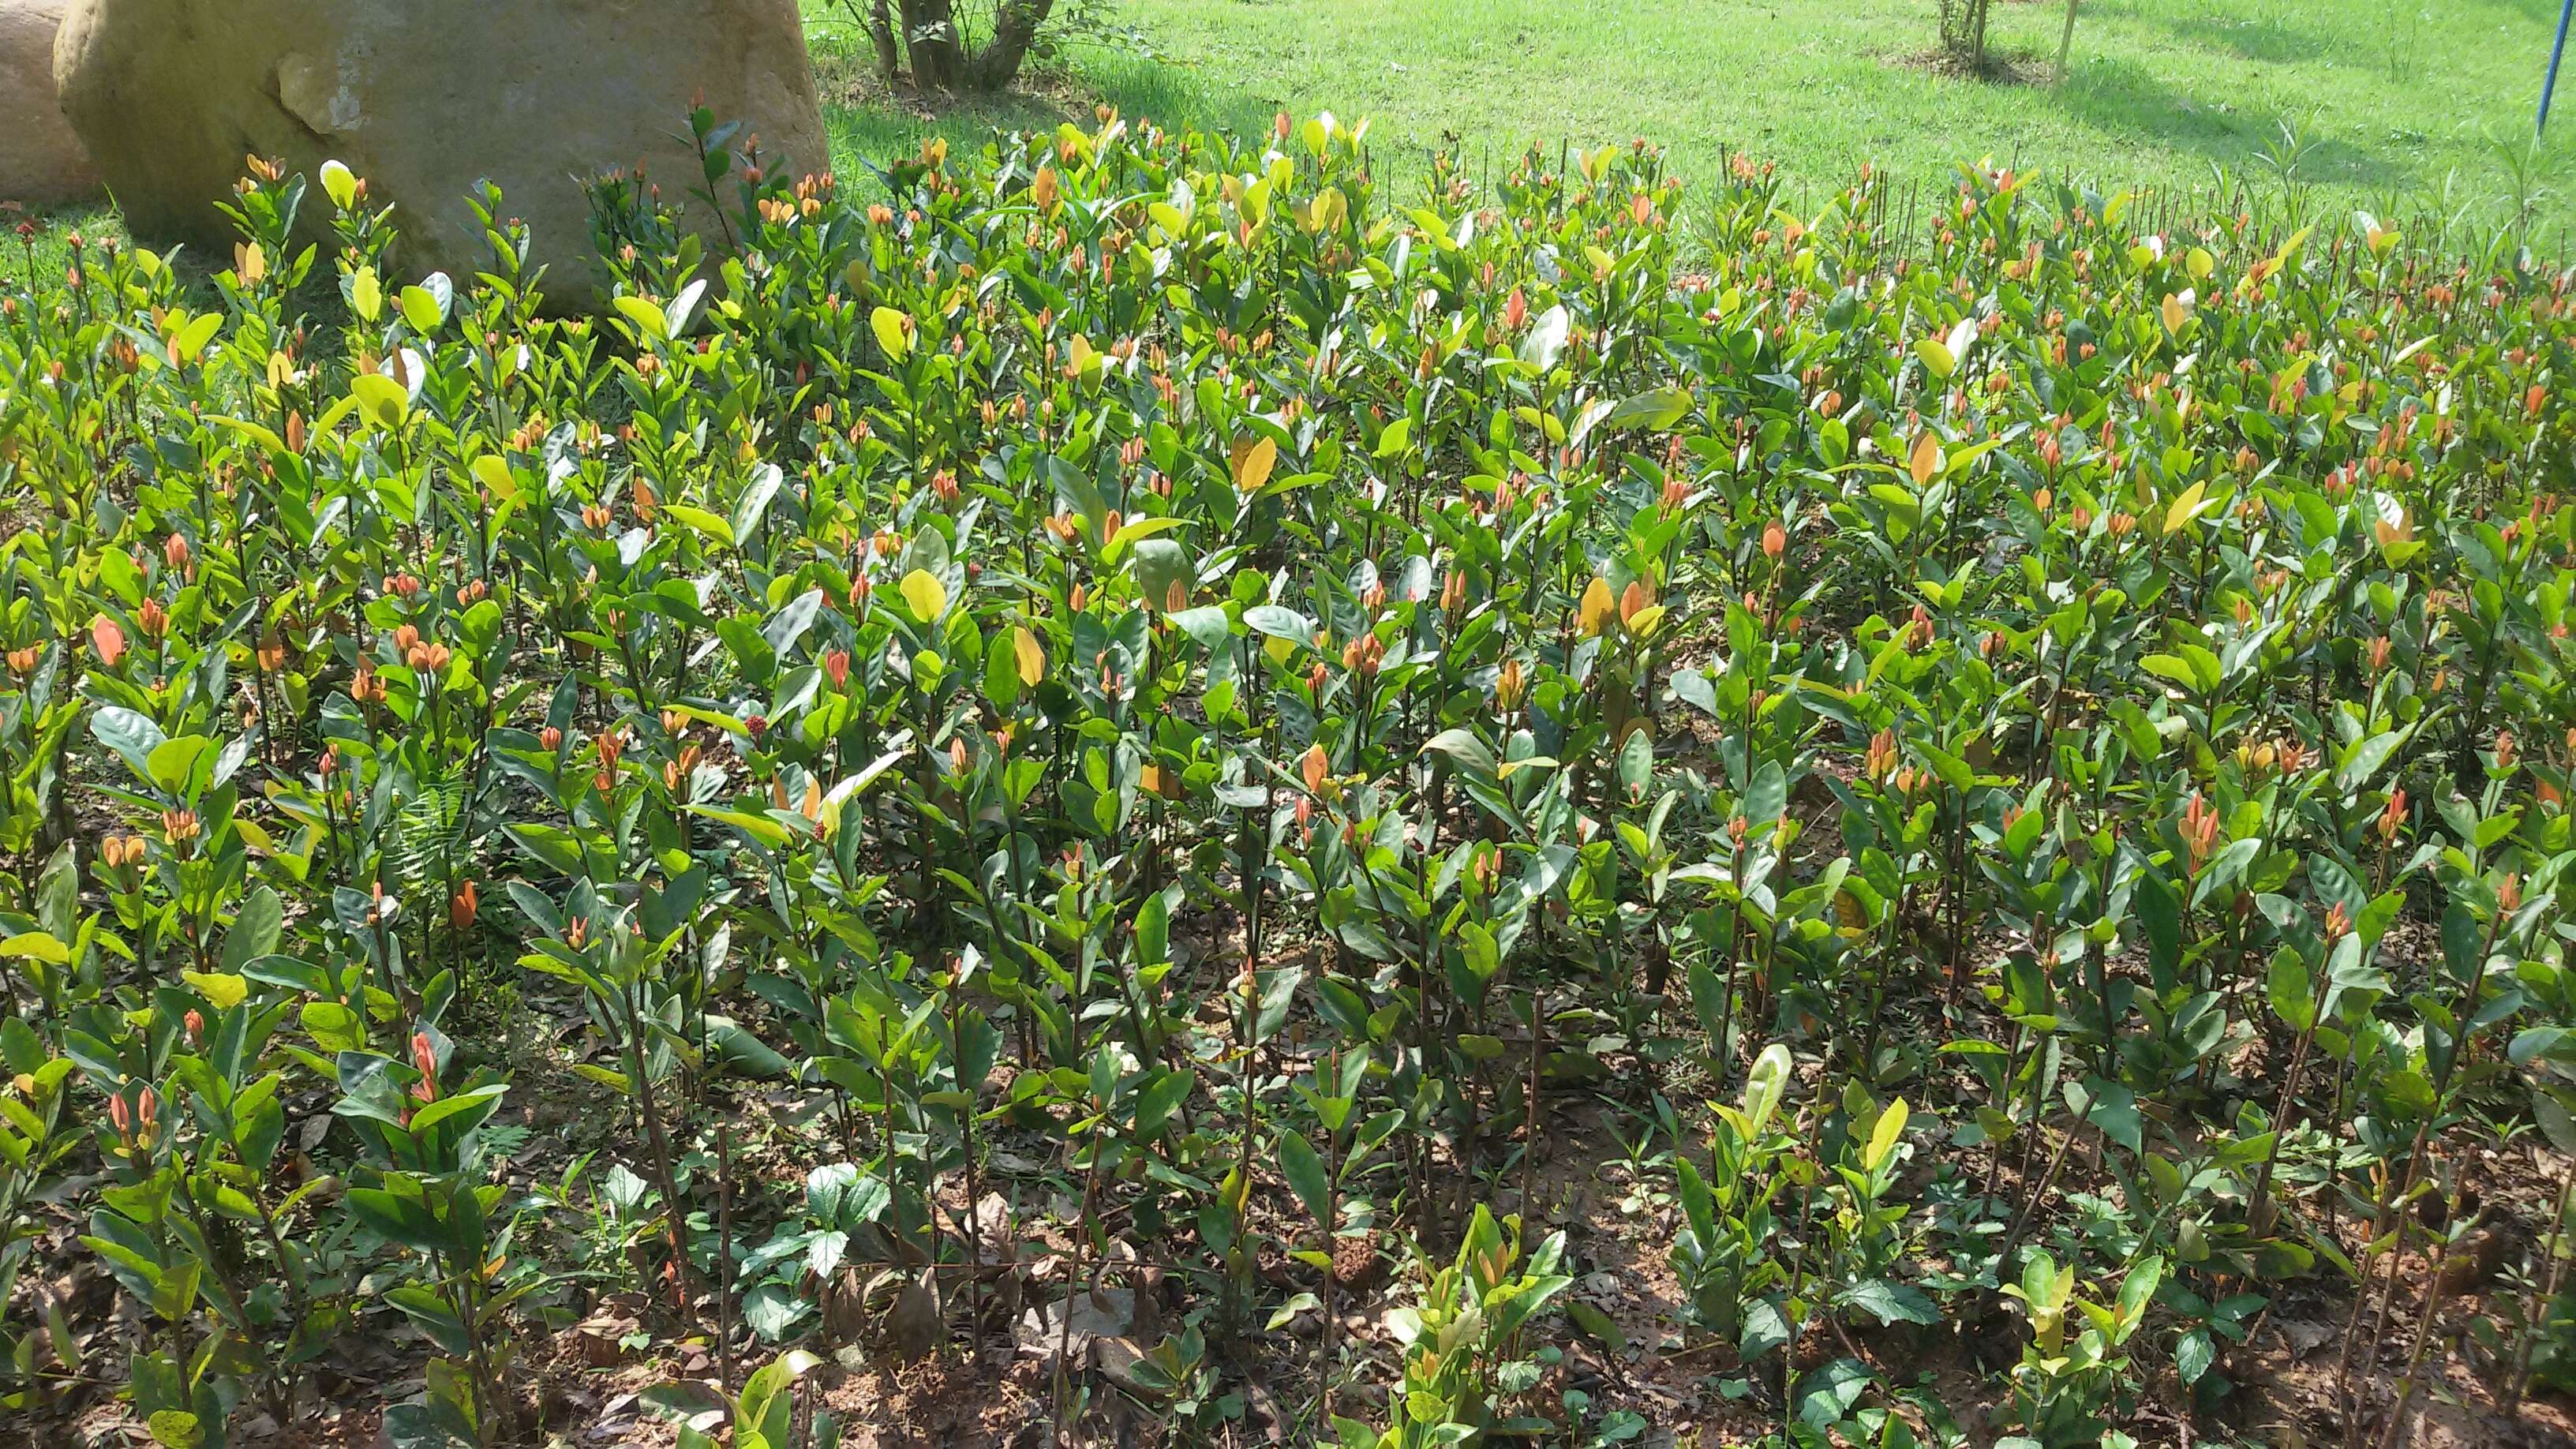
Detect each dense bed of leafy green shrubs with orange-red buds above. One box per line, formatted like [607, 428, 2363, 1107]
[0, 95, 2576, 1449]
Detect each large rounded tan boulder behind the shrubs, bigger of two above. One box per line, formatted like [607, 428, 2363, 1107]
[54, 0, 832, 297]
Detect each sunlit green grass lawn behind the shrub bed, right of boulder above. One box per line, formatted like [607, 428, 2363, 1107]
[807, 0, 2576, 238]
